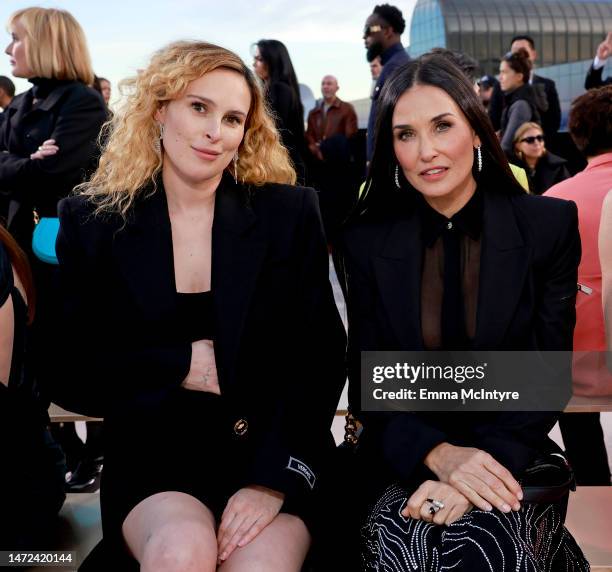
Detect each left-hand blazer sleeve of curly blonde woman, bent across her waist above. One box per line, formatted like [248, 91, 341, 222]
[56, 199, 191, 417]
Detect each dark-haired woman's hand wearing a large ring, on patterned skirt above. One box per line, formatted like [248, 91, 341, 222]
[402, 481, 474, 526]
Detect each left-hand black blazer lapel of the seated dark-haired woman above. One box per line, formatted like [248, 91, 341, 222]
[374, 213, 423, 350]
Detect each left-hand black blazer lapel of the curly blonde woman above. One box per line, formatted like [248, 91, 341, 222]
[113, 189, 176, 321]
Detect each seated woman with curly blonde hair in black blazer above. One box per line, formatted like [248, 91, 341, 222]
[57, 42, 344, 572]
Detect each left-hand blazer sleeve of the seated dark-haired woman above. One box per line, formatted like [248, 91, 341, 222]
[344, 238, 449, 480]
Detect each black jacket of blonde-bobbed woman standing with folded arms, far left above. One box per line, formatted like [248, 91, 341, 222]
[0, 80, 107, 248]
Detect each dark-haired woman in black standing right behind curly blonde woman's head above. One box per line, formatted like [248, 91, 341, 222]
[253, 40, 306, 182]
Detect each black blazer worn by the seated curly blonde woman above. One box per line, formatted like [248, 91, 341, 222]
[55, 177, 345, 504]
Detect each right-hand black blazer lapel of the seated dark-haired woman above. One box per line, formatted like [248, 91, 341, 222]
[474, 192, 530, 349]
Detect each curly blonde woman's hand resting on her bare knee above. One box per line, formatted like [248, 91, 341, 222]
[217, 485, 285, 561]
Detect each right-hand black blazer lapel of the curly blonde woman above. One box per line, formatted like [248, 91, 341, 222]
[211, 181, 267, 393]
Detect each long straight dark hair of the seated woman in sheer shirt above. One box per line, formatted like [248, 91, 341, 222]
[354, 54, 524, 214]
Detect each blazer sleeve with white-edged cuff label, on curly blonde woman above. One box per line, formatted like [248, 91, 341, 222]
[245, 189, 346, 505]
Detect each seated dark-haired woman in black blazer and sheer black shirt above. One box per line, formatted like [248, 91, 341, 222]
[344, 55, 588, 571]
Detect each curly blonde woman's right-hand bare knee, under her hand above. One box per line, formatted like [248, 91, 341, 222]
[219, 513, 310, 572]
